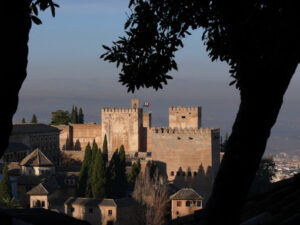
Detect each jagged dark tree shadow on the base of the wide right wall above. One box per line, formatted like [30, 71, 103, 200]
[173, 163, 213, 201]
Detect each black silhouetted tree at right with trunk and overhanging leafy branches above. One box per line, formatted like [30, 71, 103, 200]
[101, 0, 300, 225]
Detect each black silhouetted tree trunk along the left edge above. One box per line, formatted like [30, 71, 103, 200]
[0, 0, 31, 157]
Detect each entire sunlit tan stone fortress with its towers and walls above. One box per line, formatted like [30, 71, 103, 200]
[55, 99, 220, 199]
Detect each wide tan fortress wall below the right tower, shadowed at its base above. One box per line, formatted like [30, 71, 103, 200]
[151, 127, 218, 199]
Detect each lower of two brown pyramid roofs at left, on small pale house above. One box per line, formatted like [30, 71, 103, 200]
[27, 176, 58, 195]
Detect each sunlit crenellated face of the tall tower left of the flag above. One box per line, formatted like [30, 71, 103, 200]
[101, 108, 143, 153]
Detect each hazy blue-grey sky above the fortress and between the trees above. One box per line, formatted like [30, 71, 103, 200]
[14, 0, 300, 155]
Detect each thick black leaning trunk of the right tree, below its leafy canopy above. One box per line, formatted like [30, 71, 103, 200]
[200, 57, 298, 225]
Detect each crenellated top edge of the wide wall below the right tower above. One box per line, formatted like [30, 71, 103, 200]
[151, 127, 220, 135]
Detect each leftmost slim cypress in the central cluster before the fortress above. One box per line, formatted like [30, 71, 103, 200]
[77, 143, 92, 197]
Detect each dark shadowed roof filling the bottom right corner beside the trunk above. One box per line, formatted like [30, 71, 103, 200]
[241, 174, 300, 225]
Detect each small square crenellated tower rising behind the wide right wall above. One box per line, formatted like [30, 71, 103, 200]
[169, 106, 201, 129]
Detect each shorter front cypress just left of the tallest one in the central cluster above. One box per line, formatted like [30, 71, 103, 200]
[92, 150, 107, 198]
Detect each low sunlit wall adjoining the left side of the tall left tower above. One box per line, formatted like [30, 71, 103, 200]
[71, 124, 103, 151]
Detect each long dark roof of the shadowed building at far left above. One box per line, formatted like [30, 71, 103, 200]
[11, 123, 60, 135]
